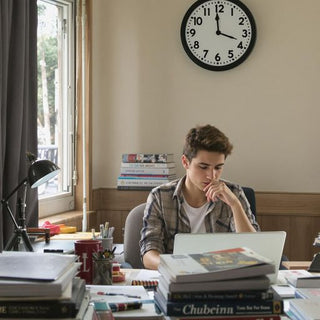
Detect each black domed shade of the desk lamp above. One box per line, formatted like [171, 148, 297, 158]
[28, 160, 60, 188]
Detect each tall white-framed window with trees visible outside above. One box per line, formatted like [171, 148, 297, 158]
[37, 0, 75, 217]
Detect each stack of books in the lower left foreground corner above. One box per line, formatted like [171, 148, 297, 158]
[0, 252, 90, 320]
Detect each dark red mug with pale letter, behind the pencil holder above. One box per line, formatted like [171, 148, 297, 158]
[74, 240, 102, 284]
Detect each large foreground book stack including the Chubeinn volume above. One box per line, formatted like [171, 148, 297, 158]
[154, 248, 284, 320]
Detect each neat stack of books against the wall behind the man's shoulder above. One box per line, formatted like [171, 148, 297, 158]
[117, 153, 176, 190]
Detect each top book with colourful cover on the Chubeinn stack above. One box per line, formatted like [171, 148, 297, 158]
[158, 247, 275, 282]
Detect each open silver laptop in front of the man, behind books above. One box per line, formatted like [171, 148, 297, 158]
[173, 231, 286, 283]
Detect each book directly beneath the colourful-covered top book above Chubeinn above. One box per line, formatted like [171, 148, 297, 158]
[158, 276, 270, 292]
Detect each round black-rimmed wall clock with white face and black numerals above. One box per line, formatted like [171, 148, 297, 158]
[181, 0, 256, 71]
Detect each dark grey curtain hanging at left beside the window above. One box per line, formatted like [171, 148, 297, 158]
[0, 0, 38, 251]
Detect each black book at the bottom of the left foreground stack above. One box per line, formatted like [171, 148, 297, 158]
[0, 277, 86, 319]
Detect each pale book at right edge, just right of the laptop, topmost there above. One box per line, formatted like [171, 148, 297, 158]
[284, 270, 320, 288]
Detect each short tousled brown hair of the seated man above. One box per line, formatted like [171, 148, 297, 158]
[183, 124, 233, 161]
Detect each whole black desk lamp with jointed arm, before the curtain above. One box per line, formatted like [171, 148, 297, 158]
[1, 152, 60, 251]
